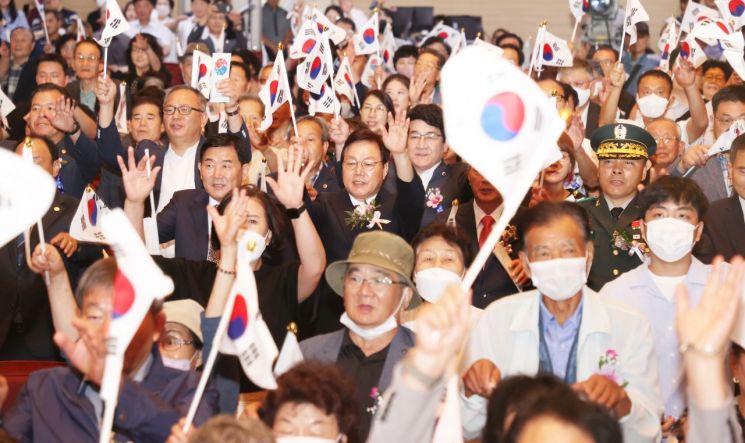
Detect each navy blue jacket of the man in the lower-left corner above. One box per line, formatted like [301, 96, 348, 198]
[5, 345, 217, 443]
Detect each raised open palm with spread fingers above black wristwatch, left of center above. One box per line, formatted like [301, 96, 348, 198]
[266, 143, 312, 209]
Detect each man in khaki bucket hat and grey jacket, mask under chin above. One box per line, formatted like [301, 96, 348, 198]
[300, 231, 420, 441]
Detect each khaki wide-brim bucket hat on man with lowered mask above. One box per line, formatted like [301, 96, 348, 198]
[326, 231, 422, 309]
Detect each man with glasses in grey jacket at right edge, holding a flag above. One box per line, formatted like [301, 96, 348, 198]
[669, 85, 745, 201]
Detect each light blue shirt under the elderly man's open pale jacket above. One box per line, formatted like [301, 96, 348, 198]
[541, 299, 583, 380]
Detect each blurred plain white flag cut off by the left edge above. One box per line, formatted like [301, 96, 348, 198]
[0, 149, 56, 247]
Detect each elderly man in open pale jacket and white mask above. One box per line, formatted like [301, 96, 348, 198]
[462, 203, 663, 443]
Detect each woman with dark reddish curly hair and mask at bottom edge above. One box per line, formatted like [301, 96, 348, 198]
[259, 361, 360, 443]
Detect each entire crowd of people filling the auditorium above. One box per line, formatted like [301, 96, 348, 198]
[0, 0, 745, 443]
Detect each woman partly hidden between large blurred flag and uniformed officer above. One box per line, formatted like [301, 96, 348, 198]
[529, 133, 576, 207]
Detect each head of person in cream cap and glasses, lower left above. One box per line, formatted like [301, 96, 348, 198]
[159, 300, 204, 371]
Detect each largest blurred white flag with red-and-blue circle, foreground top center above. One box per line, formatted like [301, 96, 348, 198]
[441, 46, 565, 234]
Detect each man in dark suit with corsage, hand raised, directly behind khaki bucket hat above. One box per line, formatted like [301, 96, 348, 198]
[305, 128, 424, 332]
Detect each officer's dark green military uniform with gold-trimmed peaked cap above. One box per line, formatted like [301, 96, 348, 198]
[578, 123, 657, 291]
